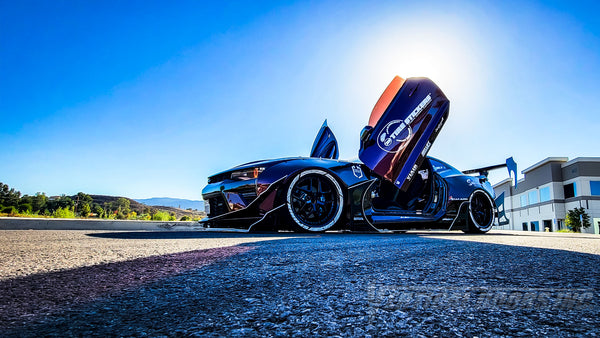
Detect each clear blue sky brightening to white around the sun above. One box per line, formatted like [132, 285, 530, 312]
[0, 0, 600, 199]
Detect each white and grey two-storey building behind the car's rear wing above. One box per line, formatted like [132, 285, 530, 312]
[494, 157, 600, 234]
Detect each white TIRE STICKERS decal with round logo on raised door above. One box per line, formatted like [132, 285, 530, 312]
[377, 93, 432, 153]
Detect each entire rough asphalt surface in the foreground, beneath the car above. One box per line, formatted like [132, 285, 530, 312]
[0, 231, 600, 337]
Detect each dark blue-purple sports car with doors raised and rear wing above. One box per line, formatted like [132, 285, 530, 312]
[200, 76, 516, 233]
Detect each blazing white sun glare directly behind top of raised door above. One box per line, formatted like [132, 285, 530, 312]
[357, 17, 486, 118]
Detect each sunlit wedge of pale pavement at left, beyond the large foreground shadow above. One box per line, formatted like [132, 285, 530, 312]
[0, 230, 292, 280]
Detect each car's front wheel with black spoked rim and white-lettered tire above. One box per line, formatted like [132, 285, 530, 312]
[286, 169, 344, 232]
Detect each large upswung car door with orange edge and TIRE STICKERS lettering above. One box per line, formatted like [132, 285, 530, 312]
[358, 76, 450, 191]
